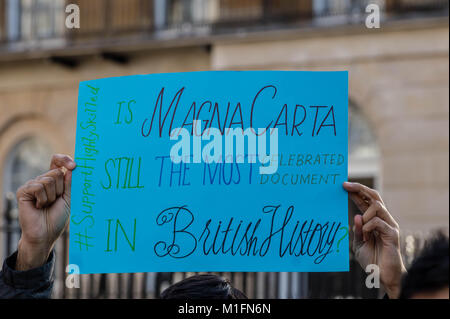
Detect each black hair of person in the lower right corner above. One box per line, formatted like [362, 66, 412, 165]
[400, 232, 449, 299]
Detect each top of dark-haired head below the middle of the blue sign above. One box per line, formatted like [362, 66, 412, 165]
[161, 274, 247, 299]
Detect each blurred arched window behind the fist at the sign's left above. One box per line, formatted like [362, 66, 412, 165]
[0, 137, 52, 255]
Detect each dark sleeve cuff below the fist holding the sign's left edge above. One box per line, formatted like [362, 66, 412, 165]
[0, 251, 55, 299]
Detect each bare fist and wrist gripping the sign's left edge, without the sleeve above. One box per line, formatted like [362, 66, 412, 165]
[16, 154, 76, 271]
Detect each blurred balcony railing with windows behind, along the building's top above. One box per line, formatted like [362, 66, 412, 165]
[0, 0, 449, 52]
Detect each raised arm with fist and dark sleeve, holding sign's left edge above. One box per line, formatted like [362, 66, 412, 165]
[0, 155, 75, 298]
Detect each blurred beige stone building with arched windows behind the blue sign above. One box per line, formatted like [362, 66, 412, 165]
[0, 0, 449, 298]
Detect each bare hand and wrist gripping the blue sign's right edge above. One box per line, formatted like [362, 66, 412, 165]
[344, 182, 406, 299]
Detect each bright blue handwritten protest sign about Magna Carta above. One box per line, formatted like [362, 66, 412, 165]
[70, 71, 349, 273]
